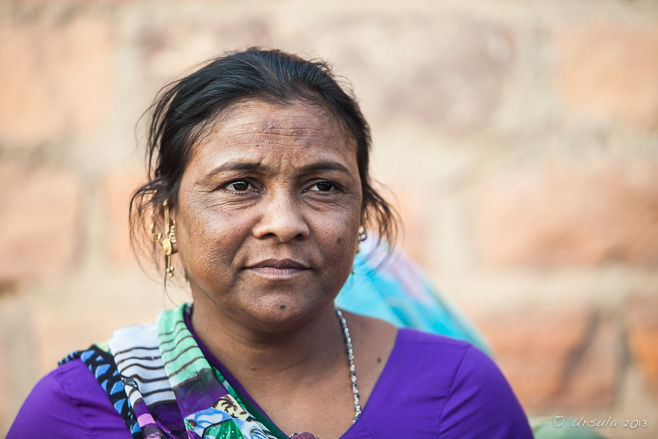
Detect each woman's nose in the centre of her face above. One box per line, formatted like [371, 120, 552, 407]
[253, 193, 310, 243]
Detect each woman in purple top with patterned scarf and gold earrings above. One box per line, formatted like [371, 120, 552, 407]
[9, 49, 531, 439]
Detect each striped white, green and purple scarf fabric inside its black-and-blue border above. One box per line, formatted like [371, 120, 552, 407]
[108, 305, 276, 439]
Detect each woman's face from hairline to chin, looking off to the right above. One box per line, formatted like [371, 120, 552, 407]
[173, 101, 362, 331]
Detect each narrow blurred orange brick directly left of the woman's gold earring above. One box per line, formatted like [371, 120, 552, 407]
[102, 168, 145, 265]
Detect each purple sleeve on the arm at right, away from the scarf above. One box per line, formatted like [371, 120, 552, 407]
[439, 347, 533, 439]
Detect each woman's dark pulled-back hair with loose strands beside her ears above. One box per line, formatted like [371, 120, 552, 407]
[130, 48, 397, 266]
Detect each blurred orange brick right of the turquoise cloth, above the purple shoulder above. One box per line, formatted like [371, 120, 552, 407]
[474, 307, 590, 409]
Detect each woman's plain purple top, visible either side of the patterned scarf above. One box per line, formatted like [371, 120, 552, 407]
[7, 321, 533, 439]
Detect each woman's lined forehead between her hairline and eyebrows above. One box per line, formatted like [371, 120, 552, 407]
[194, 101, 356, 160]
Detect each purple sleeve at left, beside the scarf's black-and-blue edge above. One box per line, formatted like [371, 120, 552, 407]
[7, 360, 132, 439]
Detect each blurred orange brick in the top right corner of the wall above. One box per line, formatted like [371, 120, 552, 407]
[555, 23, 658, 128]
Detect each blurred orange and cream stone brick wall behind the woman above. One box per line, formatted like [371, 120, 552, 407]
[0, 0, 658, 438]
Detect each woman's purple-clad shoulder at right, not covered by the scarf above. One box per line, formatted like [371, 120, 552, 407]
[352, 329, 532, 438]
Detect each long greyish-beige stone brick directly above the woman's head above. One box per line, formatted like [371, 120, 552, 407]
[138, 10, 516, 130]
